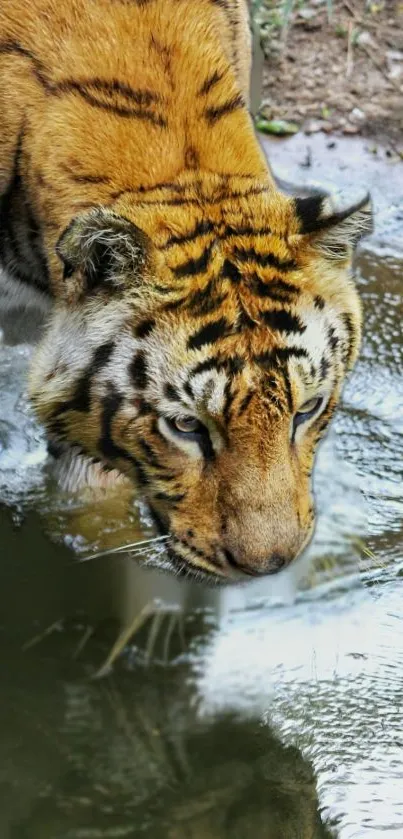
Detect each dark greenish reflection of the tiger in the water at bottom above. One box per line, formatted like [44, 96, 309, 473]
[3, 639, 332, 839]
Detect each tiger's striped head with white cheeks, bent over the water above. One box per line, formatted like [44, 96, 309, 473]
[31, 177, 369, 581]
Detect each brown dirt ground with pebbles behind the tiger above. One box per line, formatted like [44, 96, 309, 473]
[255, 0, 403, 153]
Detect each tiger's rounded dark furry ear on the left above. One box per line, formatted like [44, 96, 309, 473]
[56, 207, 153, 294]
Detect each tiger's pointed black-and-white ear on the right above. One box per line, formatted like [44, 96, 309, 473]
[294, 193, 373, 260]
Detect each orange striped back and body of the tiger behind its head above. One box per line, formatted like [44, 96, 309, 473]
[0, 0, 265, 302]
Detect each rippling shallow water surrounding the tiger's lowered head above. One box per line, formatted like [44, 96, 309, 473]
[0, 136, 403, 839]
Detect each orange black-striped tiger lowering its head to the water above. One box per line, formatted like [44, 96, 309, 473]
[0, 0, 371, 583]
